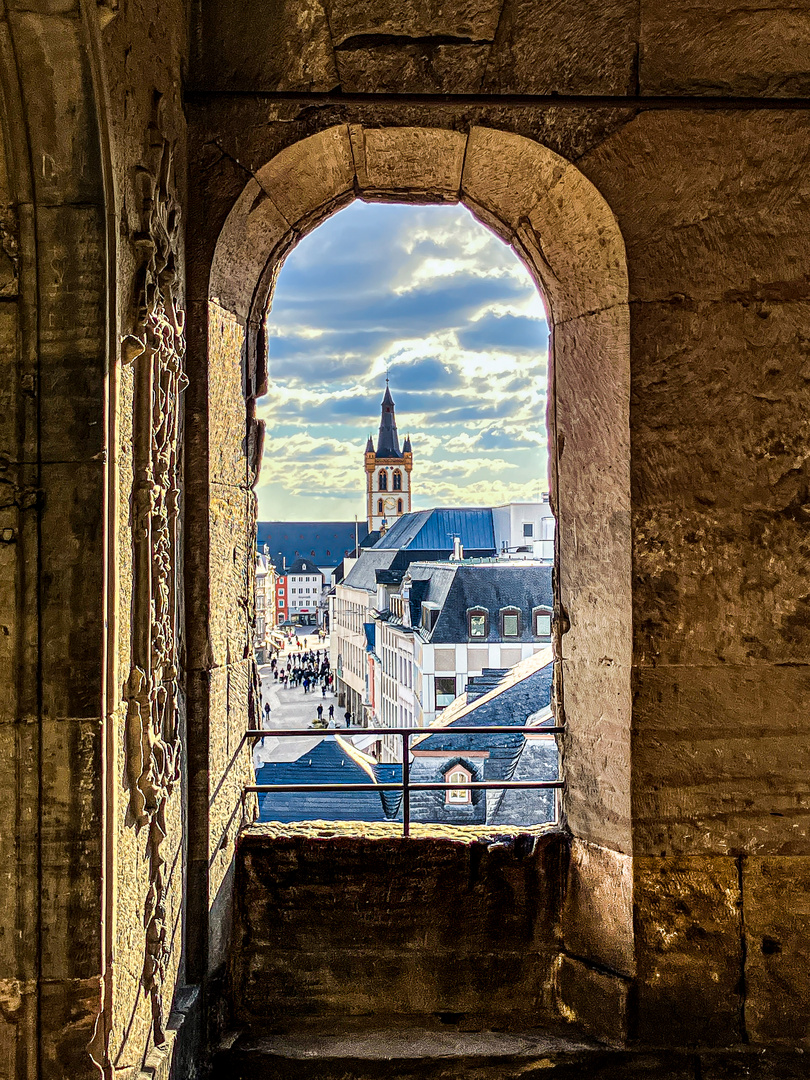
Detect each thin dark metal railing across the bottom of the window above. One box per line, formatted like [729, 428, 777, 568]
[244, 724, 565, 836]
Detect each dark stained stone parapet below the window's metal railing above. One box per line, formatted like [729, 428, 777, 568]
[231, 826, 567, 1034]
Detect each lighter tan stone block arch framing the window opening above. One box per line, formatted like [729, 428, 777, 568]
[195, 124, 633, 1019]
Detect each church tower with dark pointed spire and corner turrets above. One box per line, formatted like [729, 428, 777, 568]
[365, 379, 414, 532]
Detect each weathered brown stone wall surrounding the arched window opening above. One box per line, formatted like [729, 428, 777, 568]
[0, 0, 810, 1078]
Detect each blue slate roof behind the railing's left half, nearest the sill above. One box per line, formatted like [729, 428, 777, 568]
[256, 735, 390, 822]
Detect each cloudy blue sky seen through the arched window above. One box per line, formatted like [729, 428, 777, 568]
[257, 200, 549, 521]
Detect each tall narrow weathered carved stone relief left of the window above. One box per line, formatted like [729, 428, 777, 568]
[122, 99, 188, 1043]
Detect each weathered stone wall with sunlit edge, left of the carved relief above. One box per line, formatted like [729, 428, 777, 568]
[0, 0, 201, 1078]
